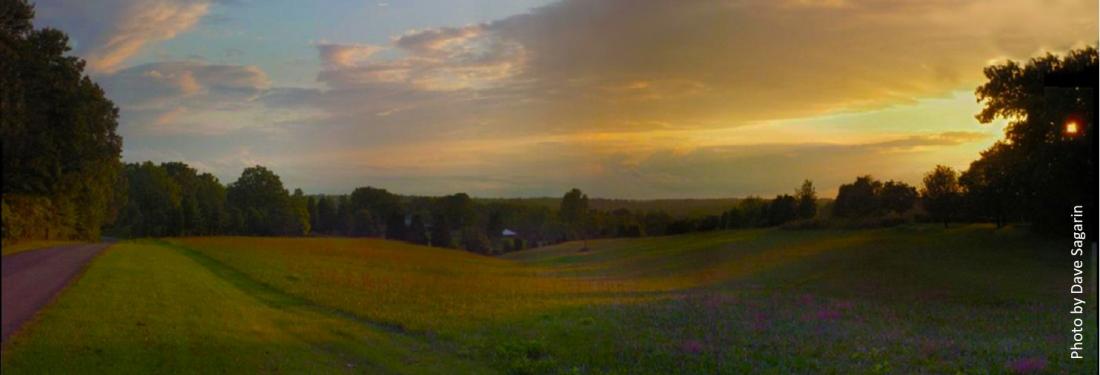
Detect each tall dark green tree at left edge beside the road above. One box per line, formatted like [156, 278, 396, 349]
[0, 0, 124, 239]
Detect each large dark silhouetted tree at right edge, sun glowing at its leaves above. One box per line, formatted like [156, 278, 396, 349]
[967, 46, 1098, 235]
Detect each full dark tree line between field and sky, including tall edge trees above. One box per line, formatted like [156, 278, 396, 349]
[0, 1, 1098, 250]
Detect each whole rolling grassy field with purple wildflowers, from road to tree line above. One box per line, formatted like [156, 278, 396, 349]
[3, 225, 1096, 374]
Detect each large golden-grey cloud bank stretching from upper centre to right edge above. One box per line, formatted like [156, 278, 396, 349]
[290, 0, 1097, 138]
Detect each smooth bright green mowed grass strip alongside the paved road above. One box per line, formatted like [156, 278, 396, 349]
[2, 242, 486, 374]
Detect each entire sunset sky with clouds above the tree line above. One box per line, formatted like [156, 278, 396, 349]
[35, 0, 1098, 199]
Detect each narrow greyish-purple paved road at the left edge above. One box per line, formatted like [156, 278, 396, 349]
[0, 242, 111, 343]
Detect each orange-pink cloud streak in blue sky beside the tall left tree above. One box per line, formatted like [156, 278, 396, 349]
[36, 0, 210, 73]
